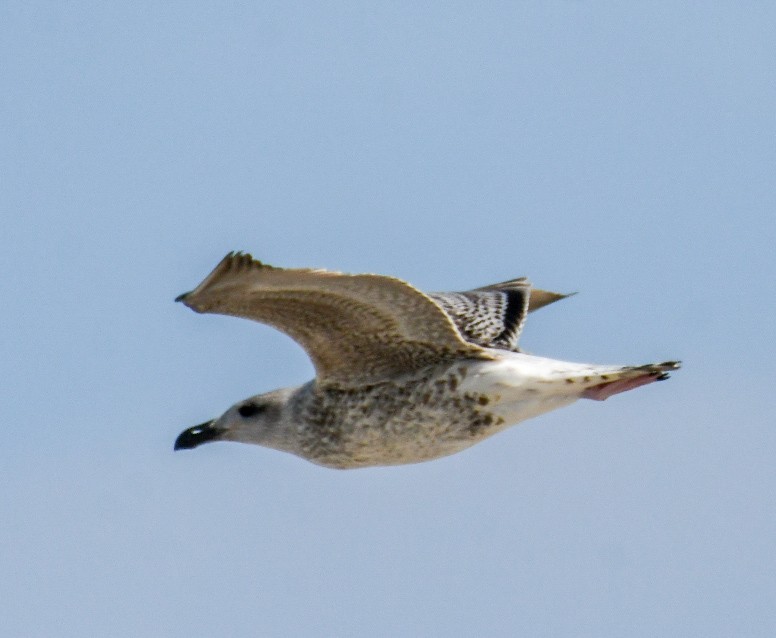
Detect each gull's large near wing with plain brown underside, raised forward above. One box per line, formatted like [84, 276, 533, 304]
[176, 253, 491, 386]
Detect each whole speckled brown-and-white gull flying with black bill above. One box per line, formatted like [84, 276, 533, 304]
[175, 252, 680, 469]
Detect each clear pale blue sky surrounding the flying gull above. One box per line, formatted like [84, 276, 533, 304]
[0, 0, 776, 638]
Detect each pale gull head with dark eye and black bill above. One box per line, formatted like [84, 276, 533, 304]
[174, 388, 293, 450]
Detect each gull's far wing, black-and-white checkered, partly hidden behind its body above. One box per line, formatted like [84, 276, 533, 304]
[429, 277, 569, 352]
